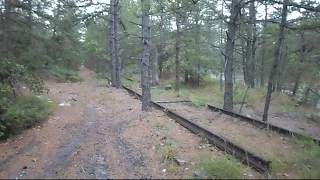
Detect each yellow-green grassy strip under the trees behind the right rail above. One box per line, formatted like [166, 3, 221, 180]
[151, 78, 319, 114]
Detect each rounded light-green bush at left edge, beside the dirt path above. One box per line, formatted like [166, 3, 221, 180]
[0, 95, 52, 137]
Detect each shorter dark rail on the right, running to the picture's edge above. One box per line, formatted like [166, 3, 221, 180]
[207, 104, 320, 146]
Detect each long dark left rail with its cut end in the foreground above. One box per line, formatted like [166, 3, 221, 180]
[123, 86, 271, 174]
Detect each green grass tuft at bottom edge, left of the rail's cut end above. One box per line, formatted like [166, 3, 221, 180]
[196, 155, 244, 179]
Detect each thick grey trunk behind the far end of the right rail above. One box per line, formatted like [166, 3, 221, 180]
[223, 0, 240, 111]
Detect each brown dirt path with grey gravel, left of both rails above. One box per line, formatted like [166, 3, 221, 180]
[0, 68, 262, 179]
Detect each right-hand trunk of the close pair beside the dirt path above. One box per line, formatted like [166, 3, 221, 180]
[114, 0, 122, 88]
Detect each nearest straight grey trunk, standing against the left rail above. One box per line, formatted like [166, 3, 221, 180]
[141, 0, 151, 111]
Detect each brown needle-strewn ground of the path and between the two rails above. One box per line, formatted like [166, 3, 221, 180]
[0, 68, 320, 179]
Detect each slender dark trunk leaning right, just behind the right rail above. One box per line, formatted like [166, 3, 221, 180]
[262, 0, 288, 121]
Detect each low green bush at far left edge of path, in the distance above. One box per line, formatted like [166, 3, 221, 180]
[50, 66, 83, 83]
